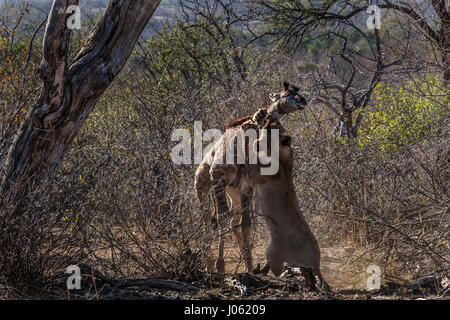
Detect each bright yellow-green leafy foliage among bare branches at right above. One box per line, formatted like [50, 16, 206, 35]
[359, 78, 448, 151]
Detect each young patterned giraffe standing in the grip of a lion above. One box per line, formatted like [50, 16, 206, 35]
[194, 82, 306, 273]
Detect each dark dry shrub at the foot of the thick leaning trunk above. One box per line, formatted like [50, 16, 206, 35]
[0, 180, 90, 297]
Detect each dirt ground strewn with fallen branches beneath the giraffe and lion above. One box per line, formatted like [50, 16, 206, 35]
[44, 225, 450, 300]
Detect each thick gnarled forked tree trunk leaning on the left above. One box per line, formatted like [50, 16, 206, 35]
[0, 0, 160, 197]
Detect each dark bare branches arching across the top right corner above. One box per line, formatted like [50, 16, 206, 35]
[254, 0, 450, 84]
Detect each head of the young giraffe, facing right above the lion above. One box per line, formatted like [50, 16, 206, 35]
[267, 82, 307, 117]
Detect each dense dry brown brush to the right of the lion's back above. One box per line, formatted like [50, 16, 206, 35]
[294, 115, 450, 277]
